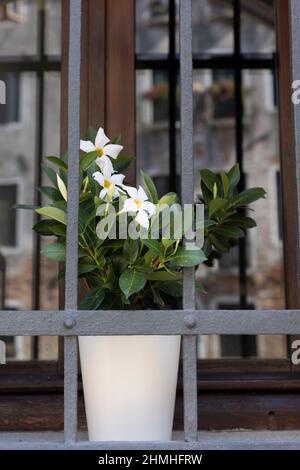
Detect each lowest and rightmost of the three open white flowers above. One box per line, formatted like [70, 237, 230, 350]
[122, 185, 156, 229]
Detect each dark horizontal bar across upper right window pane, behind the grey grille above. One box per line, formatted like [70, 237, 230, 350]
[135, 54, 276, 70]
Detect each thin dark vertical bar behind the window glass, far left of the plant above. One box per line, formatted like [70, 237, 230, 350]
[31, 1, 45, 359]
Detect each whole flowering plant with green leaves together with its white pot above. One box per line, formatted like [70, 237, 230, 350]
[19, 128, 265, 441]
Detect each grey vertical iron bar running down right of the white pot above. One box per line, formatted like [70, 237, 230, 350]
[179, 0, 198, 441]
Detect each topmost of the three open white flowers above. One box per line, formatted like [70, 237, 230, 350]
[80, 127, 123, 173]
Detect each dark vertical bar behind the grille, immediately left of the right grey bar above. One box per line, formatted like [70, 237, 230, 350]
[168, 0, 178, 191]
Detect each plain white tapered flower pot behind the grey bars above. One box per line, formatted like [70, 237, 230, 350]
[79, 336, 180, 441]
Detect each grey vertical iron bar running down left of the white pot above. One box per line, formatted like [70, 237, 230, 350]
[64, 0, 81, 442]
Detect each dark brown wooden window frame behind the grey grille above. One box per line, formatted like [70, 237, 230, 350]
[0, 0, 300, 431]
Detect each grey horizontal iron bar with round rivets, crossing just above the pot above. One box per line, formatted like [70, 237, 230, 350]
[0, 310, 300, 336]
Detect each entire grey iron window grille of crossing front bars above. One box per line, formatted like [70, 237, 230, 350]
[0, 0, 300, 450]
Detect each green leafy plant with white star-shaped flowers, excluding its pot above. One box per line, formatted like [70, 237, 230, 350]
[19, 128, 265, 310]
